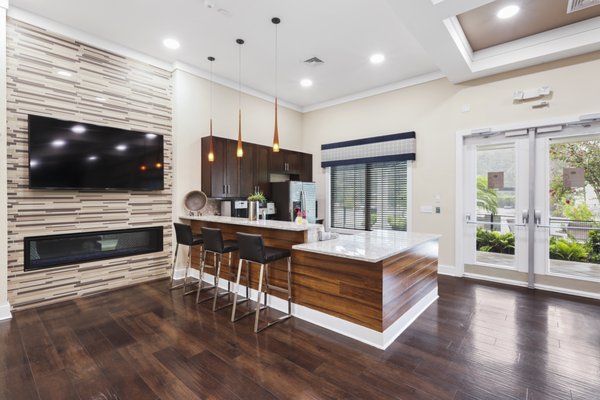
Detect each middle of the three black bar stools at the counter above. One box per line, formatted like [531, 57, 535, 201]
[196, 228, 246, 311]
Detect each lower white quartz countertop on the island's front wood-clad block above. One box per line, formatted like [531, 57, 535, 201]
[292, 230, 441, 262]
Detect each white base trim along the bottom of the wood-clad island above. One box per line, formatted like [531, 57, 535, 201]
[175, 269, 438, 350]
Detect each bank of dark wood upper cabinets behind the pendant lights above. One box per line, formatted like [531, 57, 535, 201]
[201, 137, 312, 198]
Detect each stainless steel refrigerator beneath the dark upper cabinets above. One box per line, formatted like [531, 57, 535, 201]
[271, 181, 317, 224]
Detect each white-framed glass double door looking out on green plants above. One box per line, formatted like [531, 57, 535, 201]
[463, 125, 600, 293]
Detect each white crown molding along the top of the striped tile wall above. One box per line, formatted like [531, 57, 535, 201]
[7, 6, 173, 71]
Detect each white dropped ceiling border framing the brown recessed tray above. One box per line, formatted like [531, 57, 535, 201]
[388, 0, 600, 82]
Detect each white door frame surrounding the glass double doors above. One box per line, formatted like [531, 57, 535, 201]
[453, 114, 600, 290]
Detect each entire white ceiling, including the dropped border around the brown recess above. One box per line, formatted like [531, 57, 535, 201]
[9, 0, 600, 111]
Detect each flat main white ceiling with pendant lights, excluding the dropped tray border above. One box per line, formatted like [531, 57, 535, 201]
[9, 0, 438, 109]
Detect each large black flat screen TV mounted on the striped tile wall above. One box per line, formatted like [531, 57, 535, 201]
[29, 115, 164, 190]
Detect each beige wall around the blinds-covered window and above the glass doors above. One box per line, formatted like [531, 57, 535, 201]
[303, 53, 600, 266]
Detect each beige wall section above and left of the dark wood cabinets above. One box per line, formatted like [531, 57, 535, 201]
[173, 70, 302, 221]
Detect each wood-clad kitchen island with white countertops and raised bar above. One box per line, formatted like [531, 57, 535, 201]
[181, 216, 440, 349]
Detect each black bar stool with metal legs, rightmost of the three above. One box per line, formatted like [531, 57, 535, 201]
[231, 232, 292, 333]
